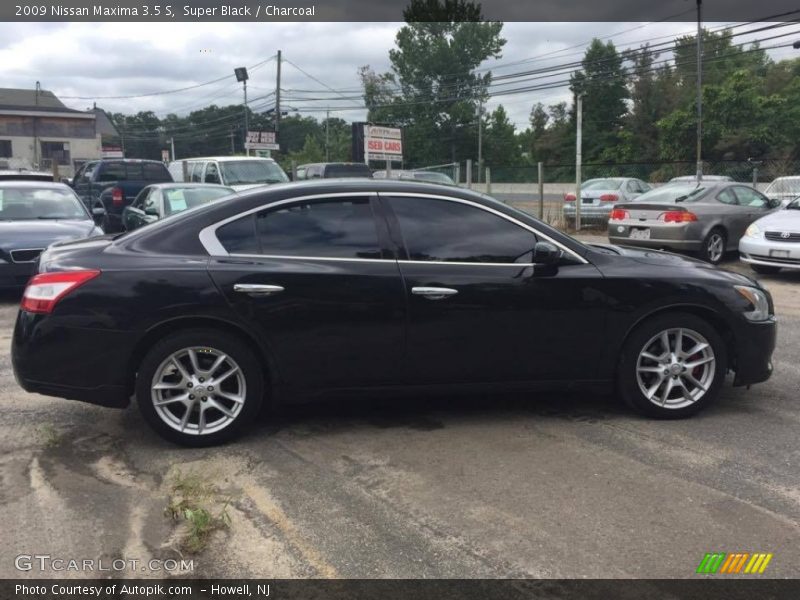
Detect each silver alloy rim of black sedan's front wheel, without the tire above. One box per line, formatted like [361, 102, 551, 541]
[636, 328, 717, 409]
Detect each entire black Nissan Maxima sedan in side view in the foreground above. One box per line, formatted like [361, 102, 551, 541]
[12, 180, 776, 445]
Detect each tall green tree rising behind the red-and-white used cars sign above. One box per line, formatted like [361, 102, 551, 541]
[361, 0, 505, 164]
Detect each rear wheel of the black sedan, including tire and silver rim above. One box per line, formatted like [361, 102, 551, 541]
[136, 329, 264, 446]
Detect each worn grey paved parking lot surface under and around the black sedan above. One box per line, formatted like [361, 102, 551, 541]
[0, 251, 800, 578]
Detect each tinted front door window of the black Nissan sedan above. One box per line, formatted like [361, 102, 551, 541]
[389, 197, 537, 263]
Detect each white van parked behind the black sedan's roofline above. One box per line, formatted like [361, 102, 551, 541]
[169, 156, 289, 192]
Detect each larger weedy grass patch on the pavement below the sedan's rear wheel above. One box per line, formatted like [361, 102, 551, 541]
[165, 471, 231, 554]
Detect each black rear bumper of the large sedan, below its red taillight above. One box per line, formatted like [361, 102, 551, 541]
[11, 311, 132, 408]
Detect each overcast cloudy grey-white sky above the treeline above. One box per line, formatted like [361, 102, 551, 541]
[0, 22, 800, 128]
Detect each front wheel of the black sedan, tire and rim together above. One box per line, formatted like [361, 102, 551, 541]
[618, 313, 726, 419]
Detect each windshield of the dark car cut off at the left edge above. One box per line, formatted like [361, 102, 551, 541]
[0, 186, 89, 221]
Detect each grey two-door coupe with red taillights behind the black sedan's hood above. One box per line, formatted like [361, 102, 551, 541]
[608, 183, 778, 264]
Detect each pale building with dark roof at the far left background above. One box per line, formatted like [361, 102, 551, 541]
[0, 88, 102, 177]
